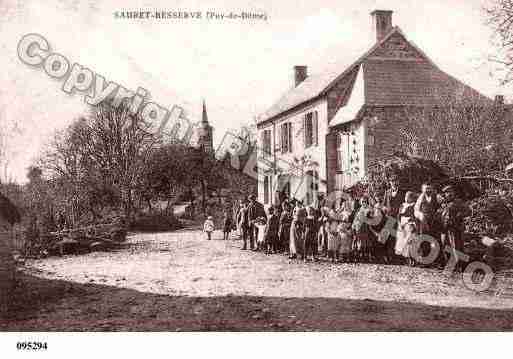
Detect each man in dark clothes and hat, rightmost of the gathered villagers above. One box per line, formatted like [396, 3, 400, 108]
[441, 185, 471, 266]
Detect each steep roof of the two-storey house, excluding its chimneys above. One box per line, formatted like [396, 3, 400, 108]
[259, 27, 492, 123]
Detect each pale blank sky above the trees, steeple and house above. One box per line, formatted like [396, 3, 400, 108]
[0, 0, 508, 182]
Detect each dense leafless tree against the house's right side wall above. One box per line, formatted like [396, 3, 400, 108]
[397, 103, 513, 175]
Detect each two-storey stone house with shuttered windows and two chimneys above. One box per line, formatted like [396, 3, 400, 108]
[257, 10, 494, 205]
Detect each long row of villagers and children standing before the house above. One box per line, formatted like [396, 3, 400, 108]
[204, 180, 470, 265]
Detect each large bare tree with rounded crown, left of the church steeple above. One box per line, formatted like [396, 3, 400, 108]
[41, 105, 158, 225]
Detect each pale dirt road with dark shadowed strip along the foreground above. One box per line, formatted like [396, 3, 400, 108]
[0, 230, 513, 331]
